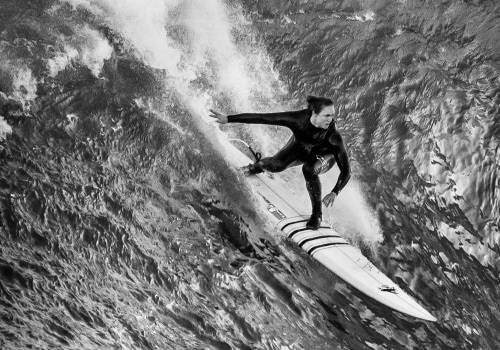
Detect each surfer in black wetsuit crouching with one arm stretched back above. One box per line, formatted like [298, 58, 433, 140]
[210, 96, 351, 229]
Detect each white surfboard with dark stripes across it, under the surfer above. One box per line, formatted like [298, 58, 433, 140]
[227, 140, 436, 322]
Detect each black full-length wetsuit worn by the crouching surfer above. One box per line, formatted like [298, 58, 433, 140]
[227, 109, 351, 224]
